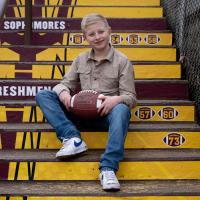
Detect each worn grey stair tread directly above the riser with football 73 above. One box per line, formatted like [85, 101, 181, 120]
[0, 122, 200, 134]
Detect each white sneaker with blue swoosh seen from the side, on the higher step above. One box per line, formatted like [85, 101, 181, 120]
[56, 137, 87, 158]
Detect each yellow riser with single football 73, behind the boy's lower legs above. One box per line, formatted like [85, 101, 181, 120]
[0, 130, 200, 149]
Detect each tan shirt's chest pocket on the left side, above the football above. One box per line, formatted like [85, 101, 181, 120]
[78, 68, 91, 90]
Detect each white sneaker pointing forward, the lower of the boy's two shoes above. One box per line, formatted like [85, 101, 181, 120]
[99, 171, 120, 190]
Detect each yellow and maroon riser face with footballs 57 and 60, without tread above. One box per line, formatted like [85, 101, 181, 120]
[0, 105, 195, 123]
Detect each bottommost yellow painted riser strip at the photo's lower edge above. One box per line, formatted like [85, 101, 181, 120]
[1, 195, 200, 200]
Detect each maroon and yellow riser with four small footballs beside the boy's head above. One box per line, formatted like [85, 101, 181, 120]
[0, 32, 172, 46]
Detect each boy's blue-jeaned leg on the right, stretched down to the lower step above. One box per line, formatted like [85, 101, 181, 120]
[100, 104, 131, 171]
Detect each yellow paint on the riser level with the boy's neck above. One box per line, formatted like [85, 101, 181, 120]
[33, 47, 176, 61]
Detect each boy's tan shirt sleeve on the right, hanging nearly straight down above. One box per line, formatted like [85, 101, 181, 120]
[119, 58, 137, 108]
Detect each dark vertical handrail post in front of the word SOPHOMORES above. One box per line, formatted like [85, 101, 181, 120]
[24, 0, 32, 45]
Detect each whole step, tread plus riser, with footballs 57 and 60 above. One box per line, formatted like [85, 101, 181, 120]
[0, 100, 195, 123]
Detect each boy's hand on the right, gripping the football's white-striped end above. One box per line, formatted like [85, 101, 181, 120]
[98, 95, 122, 116]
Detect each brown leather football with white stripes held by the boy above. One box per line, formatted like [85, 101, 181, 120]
[70, 90, 102, 119]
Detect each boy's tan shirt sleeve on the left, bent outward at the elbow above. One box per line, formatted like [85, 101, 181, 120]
[53, 57, 79, 95]
